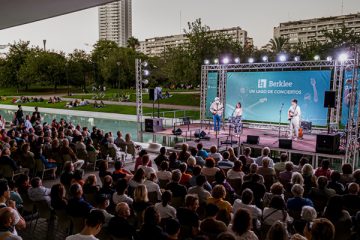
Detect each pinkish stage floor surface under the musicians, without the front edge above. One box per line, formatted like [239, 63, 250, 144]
[150, 124, 341, 155]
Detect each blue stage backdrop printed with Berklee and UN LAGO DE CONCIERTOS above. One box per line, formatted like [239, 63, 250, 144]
[225, 70, 331, 126]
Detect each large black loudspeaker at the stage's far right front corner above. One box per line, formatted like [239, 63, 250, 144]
[316, 133, 340, 154]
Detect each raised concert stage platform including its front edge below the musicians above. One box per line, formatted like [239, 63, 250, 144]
[143, 123, 345, 166]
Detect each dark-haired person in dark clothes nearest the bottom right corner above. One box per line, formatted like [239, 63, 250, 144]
[324, 195, 352, 240]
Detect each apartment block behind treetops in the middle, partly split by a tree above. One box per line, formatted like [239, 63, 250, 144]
[137, 27, 253, 56]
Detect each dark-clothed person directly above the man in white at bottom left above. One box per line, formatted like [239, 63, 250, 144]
[66, 183, 93, 217]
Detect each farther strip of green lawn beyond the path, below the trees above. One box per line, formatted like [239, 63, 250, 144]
[69, 92, 200, 107]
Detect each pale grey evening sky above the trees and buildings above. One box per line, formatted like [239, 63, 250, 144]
[0, 0, 360, 53]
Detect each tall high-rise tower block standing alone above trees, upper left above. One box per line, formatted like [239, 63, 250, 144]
[99, 0, 132, 47]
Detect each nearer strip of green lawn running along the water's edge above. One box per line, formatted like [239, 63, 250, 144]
[0, 99, 199, 119]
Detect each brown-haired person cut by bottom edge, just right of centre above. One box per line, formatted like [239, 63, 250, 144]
[231, 209, 258, 240]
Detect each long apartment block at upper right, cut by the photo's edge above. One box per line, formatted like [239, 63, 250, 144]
[274, 13, 360, 44]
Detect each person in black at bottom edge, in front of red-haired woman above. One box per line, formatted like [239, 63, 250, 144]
[200, 204, 227, 240]
